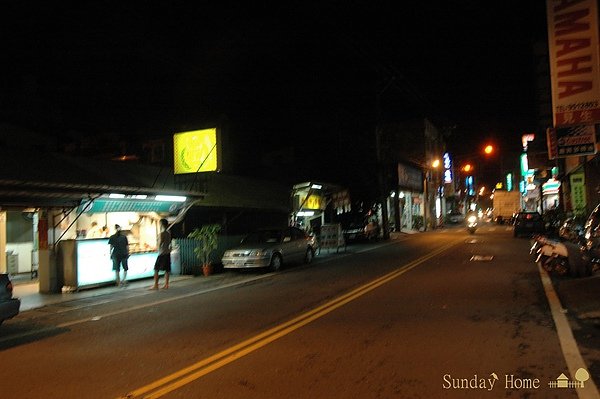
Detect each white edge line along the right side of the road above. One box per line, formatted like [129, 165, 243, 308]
[538, 263, 600, 399]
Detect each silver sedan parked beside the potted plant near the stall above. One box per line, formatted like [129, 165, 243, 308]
[221, 227, 317, 271]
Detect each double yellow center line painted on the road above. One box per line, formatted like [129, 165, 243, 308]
[119, 241, 459, 399]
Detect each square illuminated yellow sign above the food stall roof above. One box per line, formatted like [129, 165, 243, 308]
[173, 128, 218, 174]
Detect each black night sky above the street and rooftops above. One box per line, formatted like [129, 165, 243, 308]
[0, 1, 545, 191]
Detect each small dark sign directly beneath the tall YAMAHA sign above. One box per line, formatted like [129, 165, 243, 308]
[548, 125, 596, 159]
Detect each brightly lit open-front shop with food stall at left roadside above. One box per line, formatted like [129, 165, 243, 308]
[0, 183, 200, 293]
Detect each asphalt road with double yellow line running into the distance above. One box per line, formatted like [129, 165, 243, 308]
[0, 228, 598, 399]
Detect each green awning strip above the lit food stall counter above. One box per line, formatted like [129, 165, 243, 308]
[79, 198, 183, 213]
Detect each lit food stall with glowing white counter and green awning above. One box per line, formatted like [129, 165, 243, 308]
[57, 196, 185, 291]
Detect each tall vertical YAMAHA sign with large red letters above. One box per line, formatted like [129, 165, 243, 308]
[546, 0, 600, 127]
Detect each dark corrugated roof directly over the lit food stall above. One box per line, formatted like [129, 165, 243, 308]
[0, 149, 204, 207]
